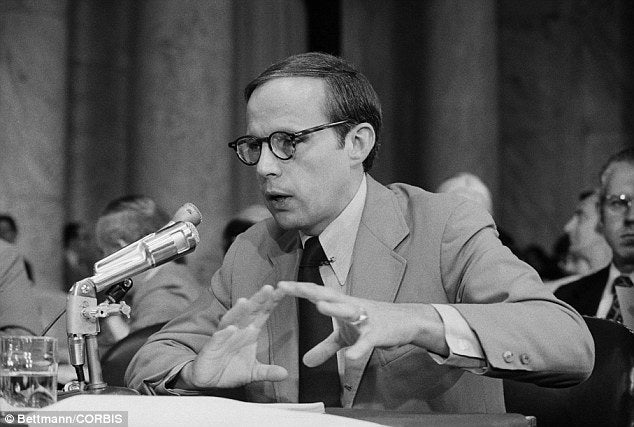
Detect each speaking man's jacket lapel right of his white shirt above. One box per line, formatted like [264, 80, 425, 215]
[342, 176, 409, 407]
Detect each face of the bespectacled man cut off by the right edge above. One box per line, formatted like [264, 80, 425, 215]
[601, 162, 634, 272]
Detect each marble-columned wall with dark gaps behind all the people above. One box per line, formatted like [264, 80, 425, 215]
[0, 0, 634, 287]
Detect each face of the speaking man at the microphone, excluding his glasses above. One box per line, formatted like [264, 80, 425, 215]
[247, 77, 362, 235]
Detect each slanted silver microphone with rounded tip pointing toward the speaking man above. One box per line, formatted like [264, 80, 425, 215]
[88, 203, 202, 292]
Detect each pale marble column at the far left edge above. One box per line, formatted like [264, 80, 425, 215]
[0, 0, 68, 287]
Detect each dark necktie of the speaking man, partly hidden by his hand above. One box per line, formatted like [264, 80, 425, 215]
[297, 237, 341, 407]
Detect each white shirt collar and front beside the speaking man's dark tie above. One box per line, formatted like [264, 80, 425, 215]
[300, 173, 368, 284]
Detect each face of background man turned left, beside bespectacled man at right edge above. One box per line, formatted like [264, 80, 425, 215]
[564, 195, 603, 253]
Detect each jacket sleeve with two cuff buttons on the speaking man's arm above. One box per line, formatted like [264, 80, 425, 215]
[441, 201, 594, 386]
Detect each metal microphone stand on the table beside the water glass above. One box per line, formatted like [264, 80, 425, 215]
[58, 278, 139, 400]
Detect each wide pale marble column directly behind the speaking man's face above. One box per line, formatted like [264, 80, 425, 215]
[129, 0, 306, 283]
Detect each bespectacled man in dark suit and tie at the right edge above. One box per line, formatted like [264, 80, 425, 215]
[555, 148, 634, 321]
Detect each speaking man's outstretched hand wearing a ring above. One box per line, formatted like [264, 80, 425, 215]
[278, 282, 449, 367]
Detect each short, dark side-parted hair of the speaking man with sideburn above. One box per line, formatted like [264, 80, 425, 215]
[244, 52, 382, 172]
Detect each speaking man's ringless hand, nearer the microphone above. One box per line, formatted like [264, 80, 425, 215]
[180, 286, 288, 389]
